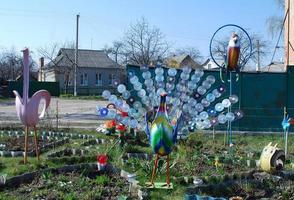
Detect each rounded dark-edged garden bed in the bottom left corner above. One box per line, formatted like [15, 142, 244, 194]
[0, 164, 134, 199]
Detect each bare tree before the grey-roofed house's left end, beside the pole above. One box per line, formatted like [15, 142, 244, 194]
[38, 42, 75, 94]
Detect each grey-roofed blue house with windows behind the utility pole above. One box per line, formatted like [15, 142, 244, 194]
[40, 48, 125, 95]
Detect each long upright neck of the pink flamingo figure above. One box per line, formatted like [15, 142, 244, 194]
[22, 48, 30, 104]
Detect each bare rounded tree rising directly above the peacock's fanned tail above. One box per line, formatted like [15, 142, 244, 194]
[108, 17, 169, 65]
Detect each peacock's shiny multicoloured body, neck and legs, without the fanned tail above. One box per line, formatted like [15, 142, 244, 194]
[145, 93, 181, 187]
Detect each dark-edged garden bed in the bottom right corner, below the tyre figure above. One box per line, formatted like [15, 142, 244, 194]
[185, 172, 294, 200]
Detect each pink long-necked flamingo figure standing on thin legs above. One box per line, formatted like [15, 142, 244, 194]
[13, 48, 51, 164]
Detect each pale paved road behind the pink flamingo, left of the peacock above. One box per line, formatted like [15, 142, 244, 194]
[0, 98, 107, 128]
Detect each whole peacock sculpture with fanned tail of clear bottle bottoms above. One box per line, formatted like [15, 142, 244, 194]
[101, 66, 243, 187]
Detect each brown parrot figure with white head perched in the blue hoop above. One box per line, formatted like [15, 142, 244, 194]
[227, 33, 240, 72]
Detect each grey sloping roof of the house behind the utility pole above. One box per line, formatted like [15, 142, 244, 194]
[48, 48, 121, 68]
